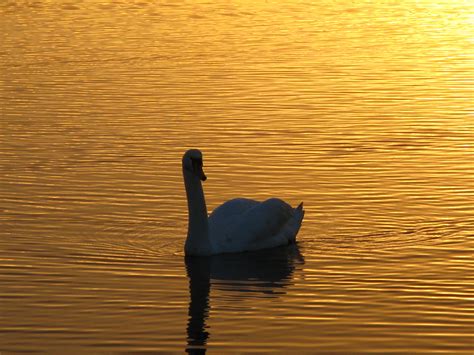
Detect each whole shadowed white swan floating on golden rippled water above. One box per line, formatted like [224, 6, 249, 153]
[182, 149, 304, 256]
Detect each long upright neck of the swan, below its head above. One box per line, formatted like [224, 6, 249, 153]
[183, 171, 212, 255]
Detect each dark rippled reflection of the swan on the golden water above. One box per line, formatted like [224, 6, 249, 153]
[185, 244, 304, 354]
